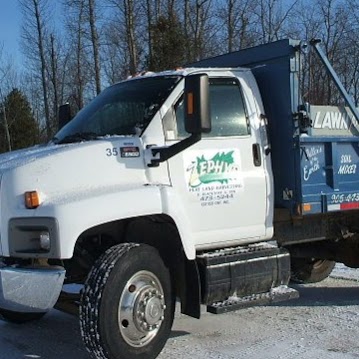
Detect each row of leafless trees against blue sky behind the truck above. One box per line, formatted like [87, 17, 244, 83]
[0, 0, 359, 152]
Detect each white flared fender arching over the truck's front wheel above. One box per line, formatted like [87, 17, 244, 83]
[54, 186, 196, 260]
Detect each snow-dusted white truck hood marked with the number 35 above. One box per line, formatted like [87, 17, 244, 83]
[0, 136, 148, 208]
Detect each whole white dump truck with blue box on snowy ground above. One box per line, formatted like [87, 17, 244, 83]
[0, 39, 359, 359]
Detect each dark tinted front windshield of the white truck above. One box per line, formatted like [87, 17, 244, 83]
[54, 76, 180, 143]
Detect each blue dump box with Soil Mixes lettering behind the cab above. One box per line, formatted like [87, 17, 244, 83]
[190, 39, 359, 215]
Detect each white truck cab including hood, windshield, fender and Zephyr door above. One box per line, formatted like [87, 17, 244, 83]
[1, 69, 273, 259]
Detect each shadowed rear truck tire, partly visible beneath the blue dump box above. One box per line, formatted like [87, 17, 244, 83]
[291, 258, 335, 283]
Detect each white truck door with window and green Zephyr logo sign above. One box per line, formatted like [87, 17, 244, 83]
[165, 77, 267, 247]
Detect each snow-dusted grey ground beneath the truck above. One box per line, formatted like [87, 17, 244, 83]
[0, 271, 359, 359]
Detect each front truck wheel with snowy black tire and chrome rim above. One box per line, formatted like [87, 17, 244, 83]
[80, 243, 175, 359]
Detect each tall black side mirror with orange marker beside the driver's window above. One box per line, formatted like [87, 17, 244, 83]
[184, 74, 211, 135]
